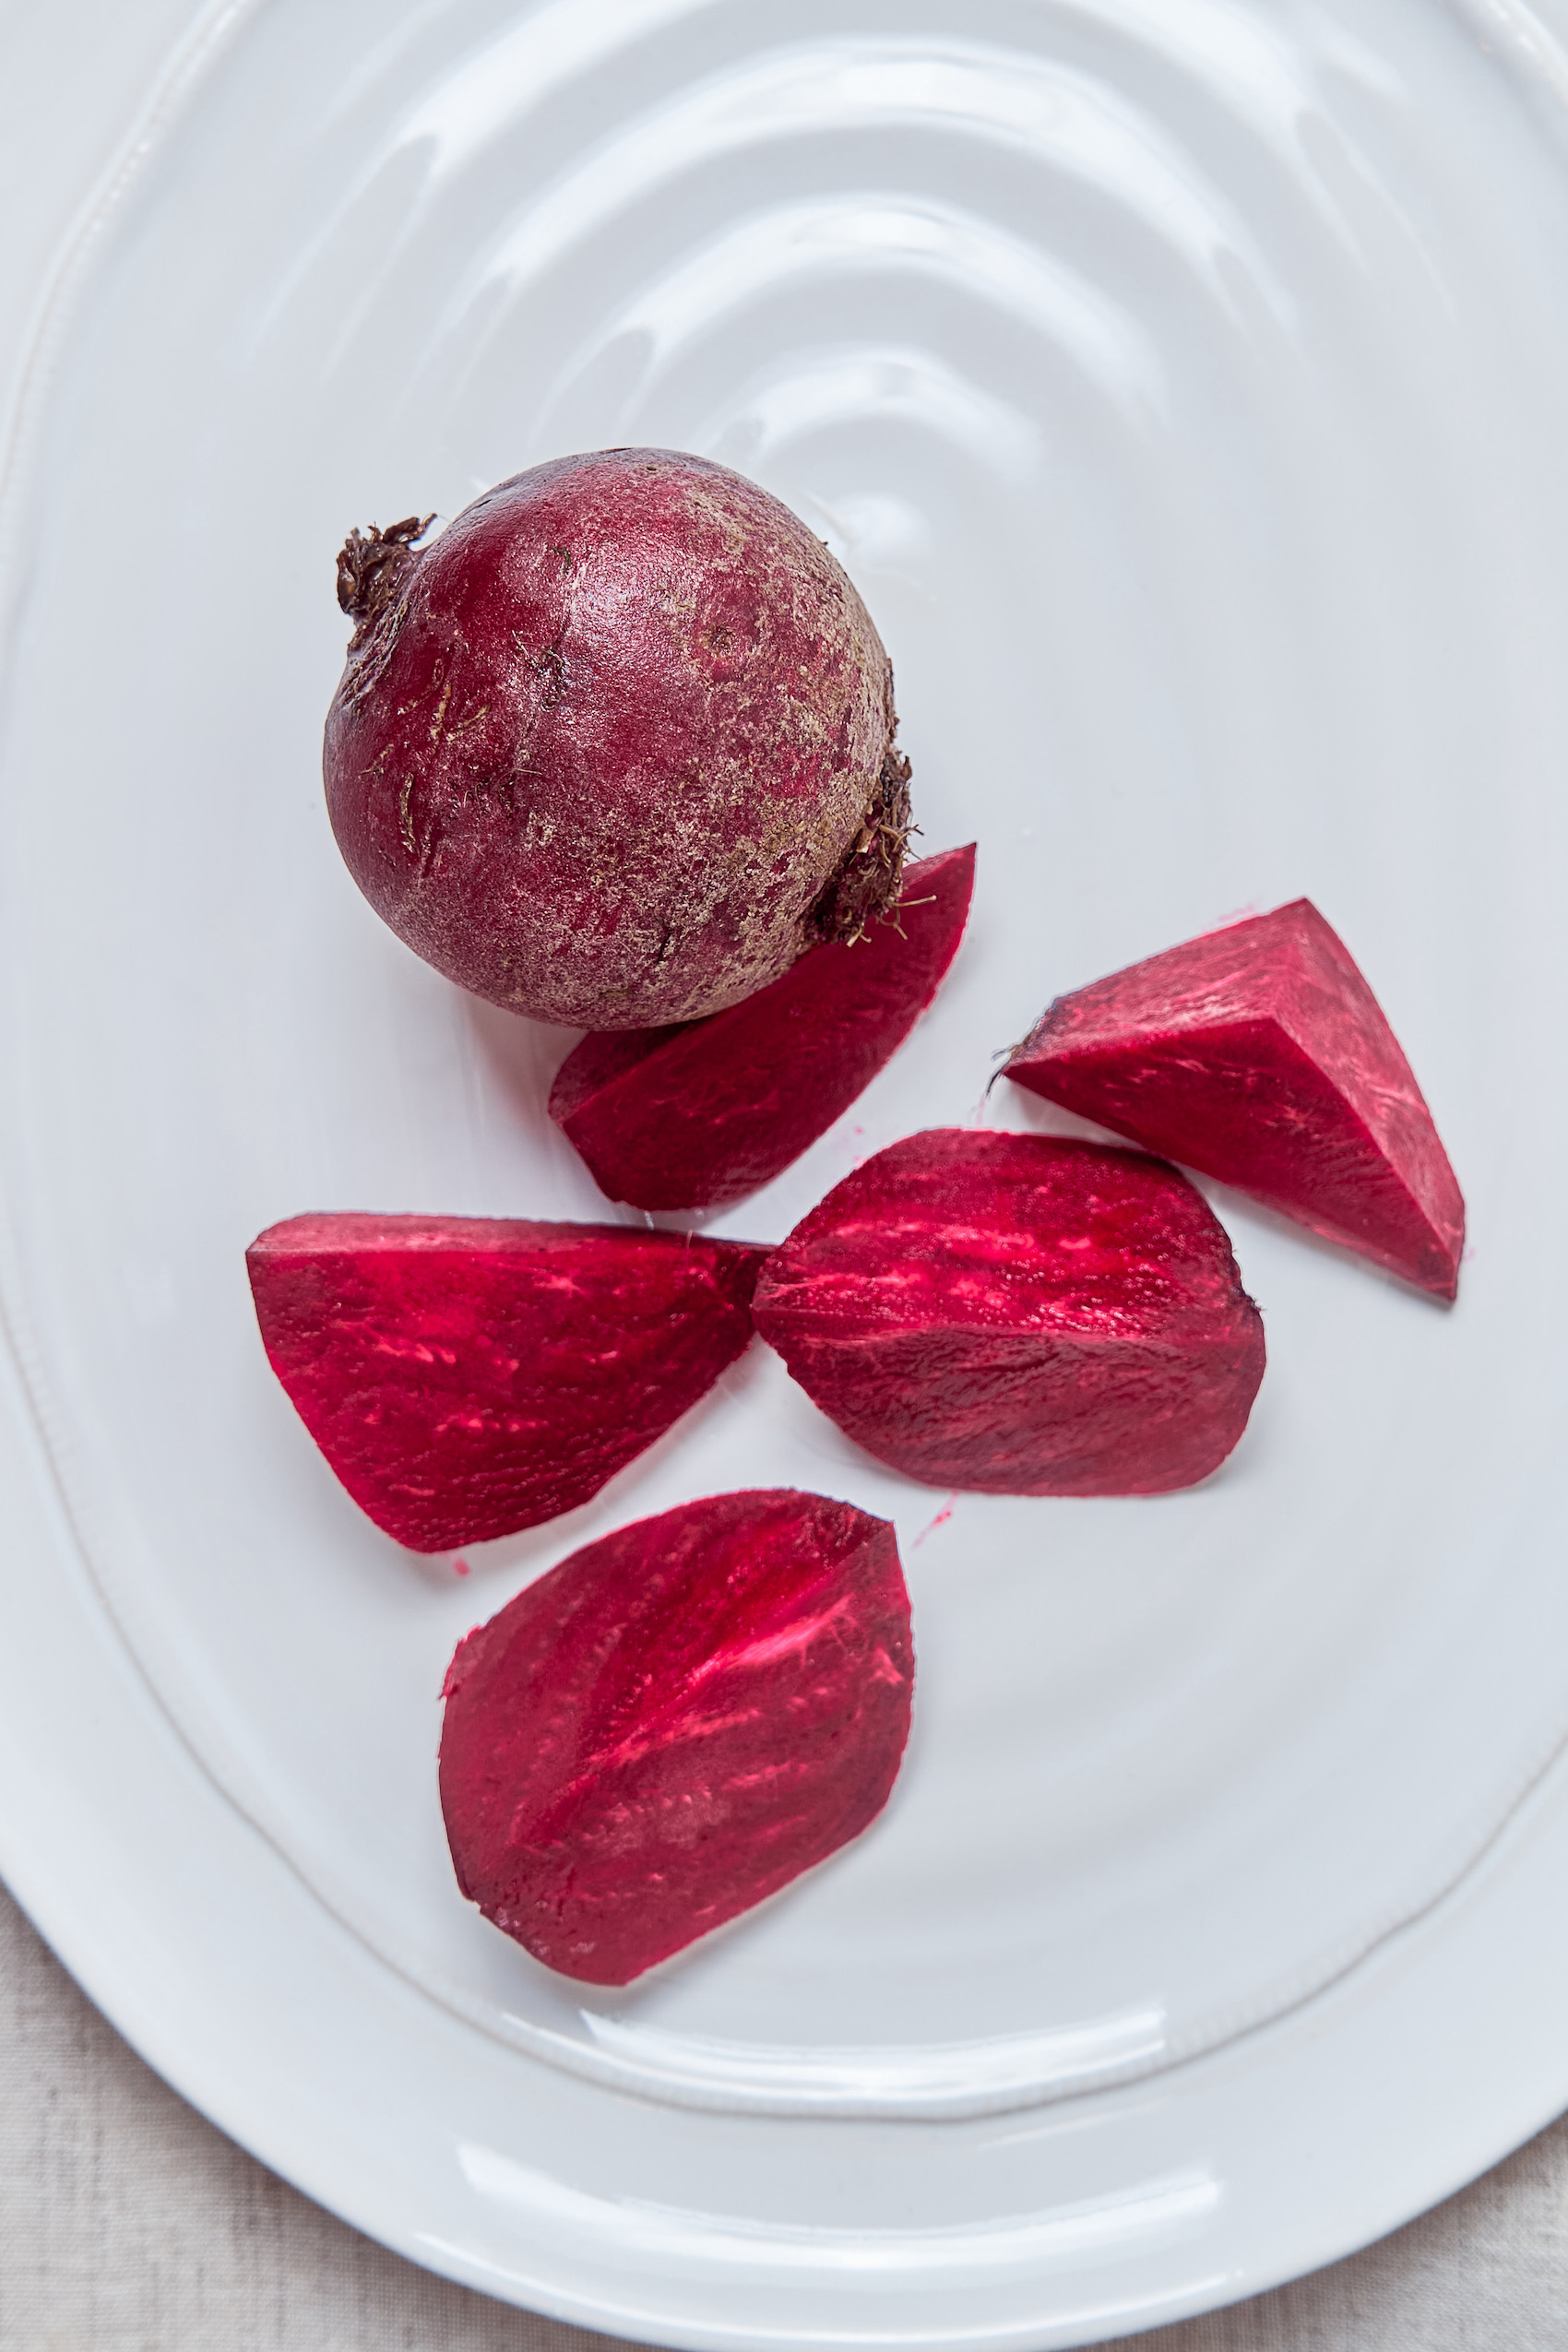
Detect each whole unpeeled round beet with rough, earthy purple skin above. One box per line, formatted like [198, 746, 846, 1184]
[325, 449, 909, 1028]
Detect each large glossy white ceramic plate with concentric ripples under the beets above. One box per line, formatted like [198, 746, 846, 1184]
[0, 0, 1568, 2345]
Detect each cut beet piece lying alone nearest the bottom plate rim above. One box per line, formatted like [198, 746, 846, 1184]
[440, 1489, 914, 1985]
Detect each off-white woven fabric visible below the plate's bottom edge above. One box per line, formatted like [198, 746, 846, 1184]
[0, 1889, 1568, 2352]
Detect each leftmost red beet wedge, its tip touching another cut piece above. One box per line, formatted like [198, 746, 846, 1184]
[244, 1216, 766, 1552]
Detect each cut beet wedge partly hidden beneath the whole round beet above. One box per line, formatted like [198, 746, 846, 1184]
[550, 842, 976, 1209]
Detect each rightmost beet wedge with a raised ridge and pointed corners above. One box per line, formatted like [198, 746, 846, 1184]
[1006, 898, 1465, 1299]
